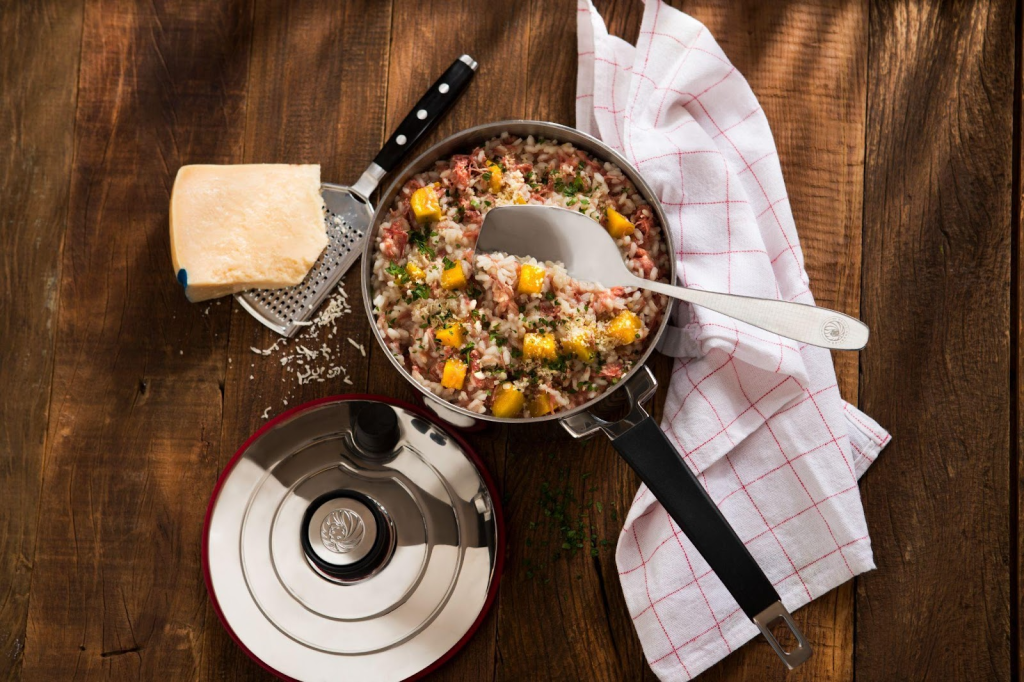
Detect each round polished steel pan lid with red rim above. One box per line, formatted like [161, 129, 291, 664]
[203, 395, 504, 682]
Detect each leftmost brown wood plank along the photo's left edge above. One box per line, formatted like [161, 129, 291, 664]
[0, 2, 82, 680]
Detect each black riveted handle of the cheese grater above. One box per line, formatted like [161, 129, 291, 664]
[374, 54, 476, 172]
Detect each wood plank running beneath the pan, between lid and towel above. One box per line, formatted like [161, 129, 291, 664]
[483, 0, 643, 680]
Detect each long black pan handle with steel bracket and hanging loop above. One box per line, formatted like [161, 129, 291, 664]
[562, 367, 812, 670]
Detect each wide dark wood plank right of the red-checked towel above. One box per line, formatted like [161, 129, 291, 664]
[856, 2, 1017, 680]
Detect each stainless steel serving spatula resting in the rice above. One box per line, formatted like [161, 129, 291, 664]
[476, 206, 868, 350]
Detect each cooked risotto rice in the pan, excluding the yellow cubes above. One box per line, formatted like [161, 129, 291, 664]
[373, 134, 668, 417]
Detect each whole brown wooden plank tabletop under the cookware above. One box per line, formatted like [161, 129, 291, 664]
[0, 0, 1024, 681]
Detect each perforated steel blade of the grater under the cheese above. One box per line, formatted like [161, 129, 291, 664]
[236, 184, 373, 337]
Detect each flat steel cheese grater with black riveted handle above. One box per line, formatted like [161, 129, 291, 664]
[234, 54, 477, 337]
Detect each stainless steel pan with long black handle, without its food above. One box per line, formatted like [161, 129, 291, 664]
[362, 121, 811, 669]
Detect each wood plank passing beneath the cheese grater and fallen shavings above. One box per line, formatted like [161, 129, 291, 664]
[202, 0, 391, 679]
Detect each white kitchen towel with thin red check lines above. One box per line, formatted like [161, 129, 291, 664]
[577, 0, 889, 680]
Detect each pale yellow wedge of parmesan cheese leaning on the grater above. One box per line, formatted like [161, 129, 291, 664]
[170, 164, 328, 301]
